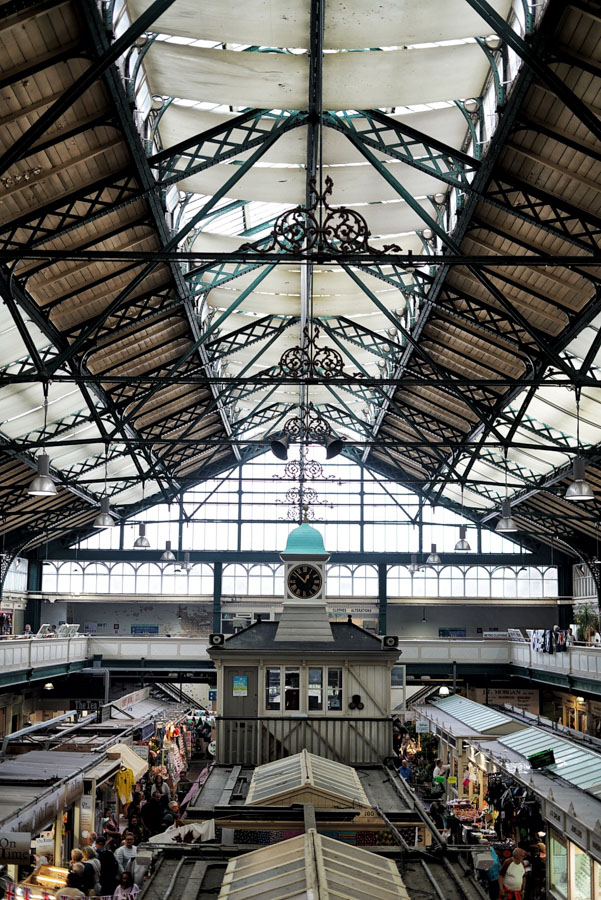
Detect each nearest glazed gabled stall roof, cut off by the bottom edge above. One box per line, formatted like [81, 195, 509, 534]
[219, 829, 409, 900]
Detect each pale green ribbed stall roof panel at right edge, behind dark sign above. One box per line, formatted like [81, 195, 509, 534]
[499, 728, 601, 799]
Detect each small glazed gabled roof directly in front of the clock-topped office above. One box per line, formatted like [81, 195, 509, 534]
[246, 750, 370, 809]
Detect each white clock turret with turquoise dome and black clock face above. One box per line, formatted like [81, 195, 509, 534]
[275, 522, 333, 642]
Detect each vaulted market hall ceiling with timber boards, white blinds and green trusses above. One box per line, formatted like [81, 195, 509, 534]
[0, 0, 601, 568]
